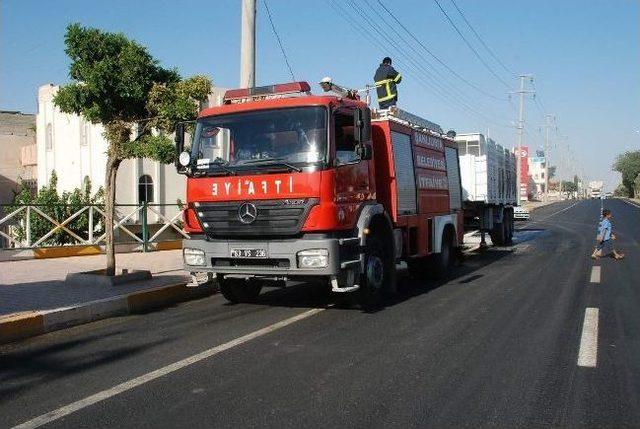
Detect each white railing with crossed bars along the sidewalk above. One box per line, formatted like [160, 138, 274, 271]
[0, 203, 188, 252]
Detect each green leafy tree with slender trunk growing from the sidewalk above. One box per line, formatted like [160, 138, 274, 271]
[54, 24, 211, 275]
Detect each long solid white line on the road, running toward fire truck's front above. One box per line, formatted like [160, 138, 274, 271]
[14, 308, 325, 429]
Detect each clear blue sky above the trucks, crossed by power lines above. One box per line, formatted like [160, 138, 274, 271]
[0, 0, 640, 186]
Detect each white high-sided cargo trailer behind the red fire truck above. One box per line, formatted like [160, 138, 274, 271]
[455, 133, 517, 246]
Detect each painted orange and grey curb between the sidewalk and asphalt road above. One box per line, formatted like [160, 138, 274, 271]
[0, 283, 217, 344]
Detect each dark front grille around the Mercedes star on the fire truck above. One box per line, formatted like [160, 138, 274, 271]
[193, 198, 318, 238]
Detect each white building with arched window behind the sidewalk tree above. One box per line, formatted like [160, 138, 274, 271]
[36, 84, 225, 222]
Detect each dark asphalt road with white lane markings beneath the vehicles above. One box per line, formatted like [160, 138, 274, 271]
[0, 200, 640, 428]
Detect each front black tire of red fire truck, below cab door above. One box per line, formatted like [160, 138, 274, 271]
[356, 235, 396, 310]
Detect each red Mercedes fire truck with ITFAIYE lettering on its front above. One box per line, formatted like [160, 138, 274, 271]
[176, 82, 463, 304]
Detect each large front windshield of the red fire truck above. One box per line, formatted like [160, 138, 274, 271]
[192, 106, 327, 171]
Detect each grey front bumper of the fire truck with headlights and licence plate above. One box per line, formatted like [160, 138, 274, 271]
[182, 236, 353, 277]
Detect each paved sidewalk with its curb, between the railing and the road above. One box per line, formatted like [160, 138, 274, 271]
[0, 250, 213, 343]
